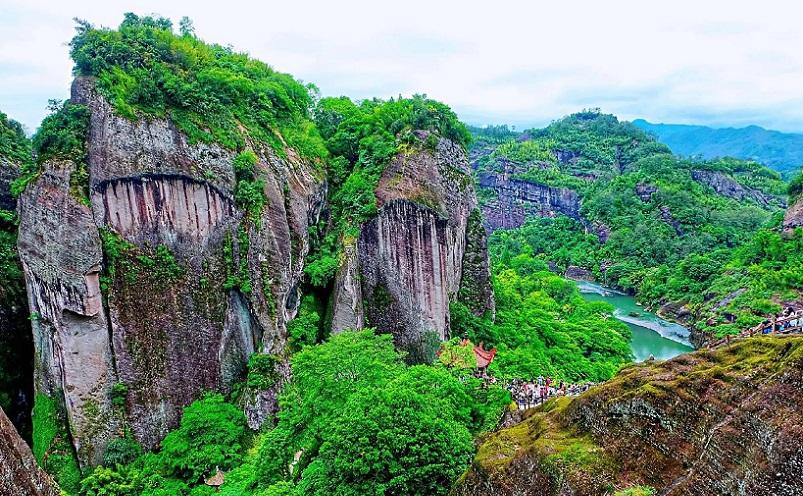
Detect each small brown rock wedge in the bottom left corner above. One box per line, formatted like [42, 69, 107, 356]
[0, 408, 60, 496]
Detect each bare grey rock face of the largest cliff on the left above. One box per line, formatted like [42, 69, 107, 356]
[18, 78, 324, 464]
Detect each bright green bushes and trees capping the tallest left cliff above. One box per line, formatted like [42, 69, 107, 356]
[70, 13, 326, 159]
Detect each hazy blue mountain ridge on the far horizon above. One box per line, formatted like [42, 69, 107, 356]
[633, 119, 803, 173]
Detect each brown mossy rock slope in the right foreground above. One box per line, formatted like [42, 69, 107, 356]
[454, 337, 803, 496]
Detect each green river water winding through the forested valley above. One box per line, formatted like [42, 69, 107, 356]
[577, 281, 694, 361]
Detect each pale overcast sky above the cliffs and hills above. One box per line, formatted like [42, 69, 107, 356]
[0, 0, 803, 132]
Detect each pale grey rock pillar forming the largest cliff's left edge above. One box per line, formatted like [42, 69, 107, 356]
[18, 162, 116, 465]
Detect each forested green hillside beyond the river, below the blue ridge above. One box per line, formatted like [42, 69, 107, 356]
[475, 111, 801, 335]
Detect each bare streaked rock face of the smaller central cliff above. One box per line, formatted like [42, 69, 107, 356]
[332, 139, 494, 348]
